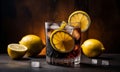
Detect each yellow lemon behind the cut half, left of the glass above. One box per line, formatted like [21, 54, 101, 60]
[19, 34, 44, 57]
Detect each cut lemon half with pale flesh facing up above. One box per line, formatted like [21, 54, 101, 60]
[7, 43, 27, 59]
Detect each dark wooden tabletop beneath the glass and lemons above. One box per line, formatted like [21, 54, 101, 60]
[0, 54, 120, 72]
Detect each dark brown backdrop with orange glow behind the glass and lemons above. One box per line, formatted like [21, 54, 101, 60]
[0, 0, 120, 53]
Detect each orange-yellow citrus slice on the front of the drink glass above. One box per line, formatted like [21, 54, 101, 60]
[50, 30, 74, 53]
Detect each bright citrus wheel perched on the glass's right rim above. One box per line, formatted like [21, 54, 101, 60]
[68, 11, 91, 32]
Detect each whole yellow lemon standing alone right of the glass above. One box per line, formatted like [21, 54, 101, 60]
[81, 39, 105, 57]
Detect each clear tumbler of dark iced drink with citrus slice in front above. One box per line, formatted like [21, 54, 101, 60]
[45, 22, 81, 66]
